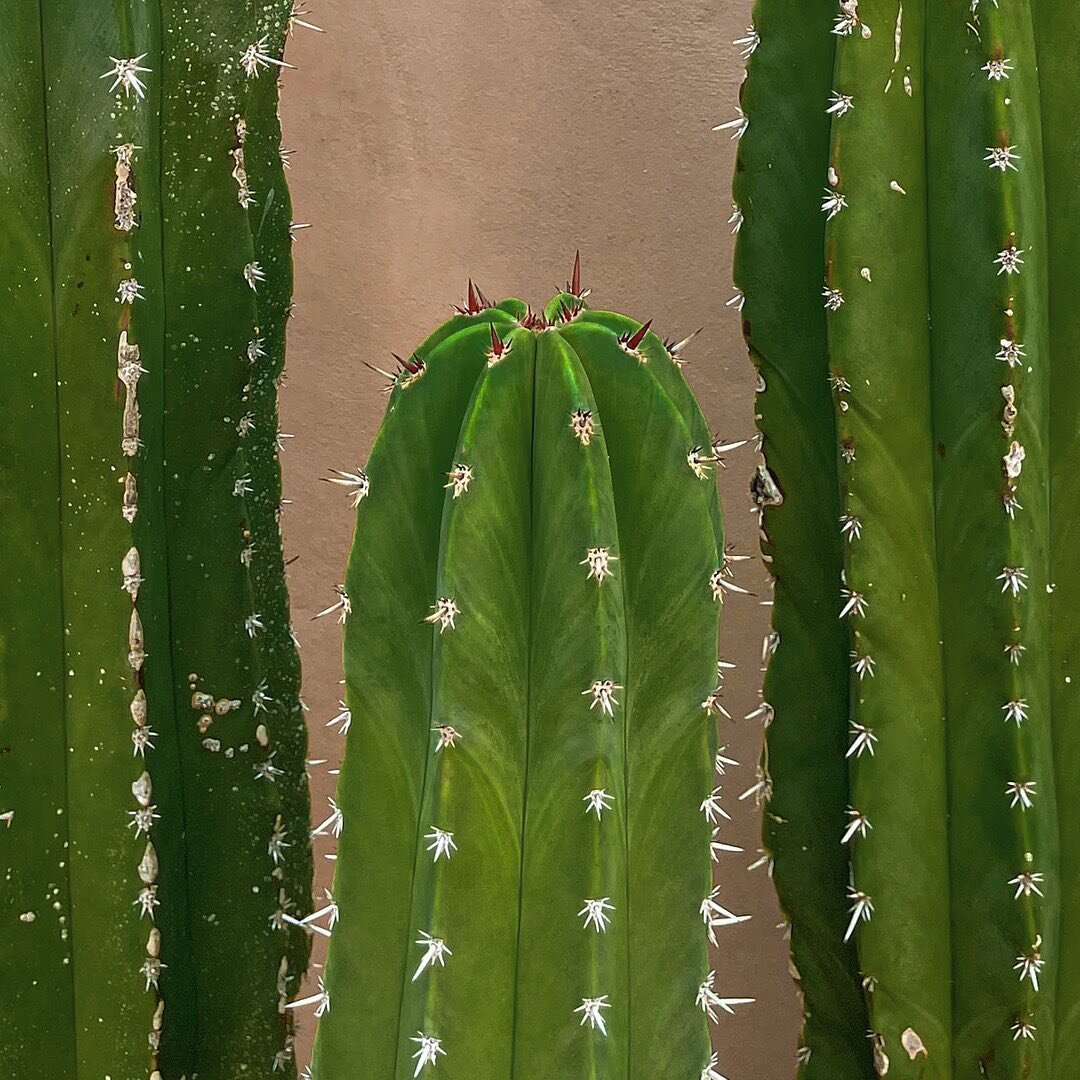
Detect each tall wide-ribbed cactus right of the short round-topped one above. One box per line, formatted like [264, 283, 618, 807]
[738, 0, 1080, 1080]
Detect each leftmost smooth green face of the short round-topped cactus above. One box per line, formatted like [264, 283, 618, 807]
[313, 319, 498, 1077]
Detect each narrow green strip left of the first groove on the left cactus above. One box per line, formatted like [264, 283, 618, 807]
[0, 12, 76, 1076]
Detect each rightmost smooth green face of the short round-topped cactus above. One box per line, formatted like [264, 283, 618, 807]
[559, 322, 733, 1080]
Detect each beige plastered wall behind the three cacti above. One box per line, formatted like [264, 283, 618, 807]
[282, 0, 798, 1080]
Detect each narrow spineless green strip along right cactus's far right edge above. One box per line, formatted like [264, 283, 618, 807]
[1032, 0, 1080, 1067]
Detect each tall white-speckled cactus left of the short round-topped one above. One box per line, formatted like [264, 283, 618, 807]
[0, 0, 311, 1080]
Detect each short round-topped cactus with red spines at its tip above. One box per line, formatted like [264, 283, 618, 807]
[304, 264, 742, 1080]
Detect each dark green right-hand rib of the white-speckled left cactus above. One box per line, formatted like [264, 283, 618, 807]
[152, 6, 309, 1080]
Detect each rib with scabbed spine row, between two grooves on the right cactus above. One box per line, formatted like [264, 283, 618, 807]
[927, 2, 1054, 1077]
